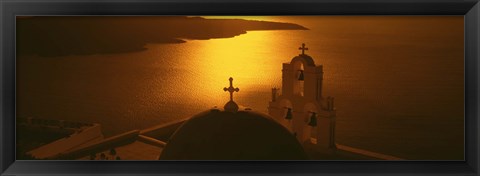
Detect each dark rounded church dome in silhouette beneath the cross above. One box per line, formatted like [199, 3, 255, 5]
[159, 109, 307, 160]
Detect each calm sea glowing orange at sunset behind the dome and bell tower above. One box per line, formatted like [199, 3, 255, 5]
[17, 16, 464, 159]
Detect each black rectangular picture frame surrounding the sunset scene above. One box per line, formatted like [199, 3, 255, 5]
[0, 0, 480, 176]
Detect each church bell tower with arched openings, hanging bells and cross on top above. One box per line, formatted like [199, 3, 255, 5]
[268, 44, 336, 149]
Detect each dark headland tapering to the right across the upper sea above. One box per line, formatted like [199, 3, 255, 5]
[17, 16, 308, 56]
